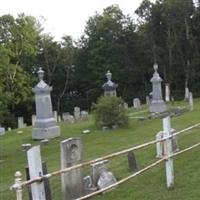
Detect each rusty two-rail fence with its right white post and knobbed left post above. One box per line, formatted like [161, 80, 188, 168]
[11, 117, 200, 200]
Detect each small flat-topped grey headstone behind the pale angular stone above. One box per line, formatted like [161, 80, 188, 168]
[91, 160, 108, 187]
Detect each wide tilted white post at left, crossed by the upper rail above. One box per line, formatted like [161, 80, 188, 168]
[27, 146, 46, 200]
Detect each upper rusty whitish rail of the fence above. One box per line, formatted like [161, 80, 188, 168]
[11, 123, 200, 187]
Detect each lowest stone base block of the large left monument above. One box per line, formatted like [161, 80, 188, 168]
[32, 126, 60, 140]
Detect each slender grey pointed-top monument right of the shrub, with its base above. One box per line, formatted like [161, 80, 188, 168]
[149, 63, 167, 113]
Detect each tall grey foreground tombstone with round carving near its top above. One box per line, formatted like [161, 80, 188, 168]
[60, 138, 84, 200]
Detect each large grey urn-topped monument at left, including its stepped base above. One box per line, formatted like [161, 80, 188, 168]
[32, 68, 60, 140]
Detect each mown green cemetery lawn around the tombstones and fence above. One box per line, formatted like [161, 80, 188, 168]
[0, 100, 200, 200]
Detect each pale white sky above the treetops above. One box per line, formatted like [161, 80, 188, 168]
[0, 0, 147, 40]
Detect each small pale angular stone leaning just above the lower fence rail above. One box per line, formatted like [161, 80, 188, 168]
[97, 172, 117, 189]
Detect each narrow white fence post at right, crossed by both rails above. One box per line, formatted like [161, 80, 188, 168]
[163, 116, 174, 190]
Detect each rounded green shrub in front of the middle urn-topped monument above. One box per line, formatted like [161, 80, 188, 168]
[93, 96, 128, 128]
